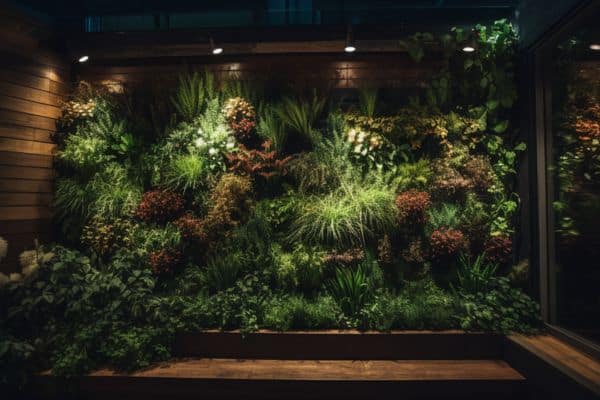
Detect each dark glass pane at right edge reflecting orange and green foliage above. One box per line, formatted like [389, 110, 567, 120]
[551, 28, 600, 342]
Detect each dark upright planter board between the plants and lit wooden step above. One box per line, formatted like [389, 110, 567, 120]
[174, 331, 502, 360]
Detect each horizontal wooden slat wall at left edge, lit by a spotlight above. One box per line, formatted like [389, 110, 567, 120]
[0, 9, 69, 272]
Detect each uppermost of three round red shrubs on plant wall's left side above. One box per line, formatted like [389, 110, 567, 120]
[136, 190, 184, 223]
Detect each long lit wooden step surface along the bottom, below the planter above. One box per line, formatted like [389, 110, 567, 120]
[89, 359, 524, 382]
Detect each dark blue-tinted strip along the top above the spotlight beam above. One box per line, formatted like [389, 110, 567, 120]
[7, 0, 518, 31]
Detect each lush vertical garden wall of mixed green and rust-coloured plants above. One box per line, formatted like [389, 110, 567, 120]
[0, 21, 539, 382]
